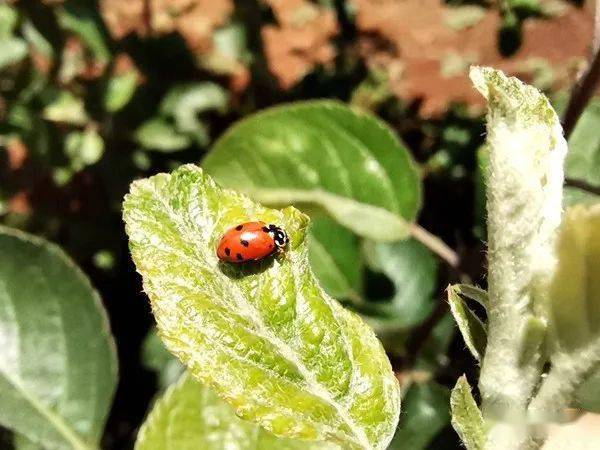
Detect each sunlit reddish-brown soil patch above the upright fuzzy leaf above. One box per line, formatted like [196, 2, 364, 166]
[356, 0, 592, 117]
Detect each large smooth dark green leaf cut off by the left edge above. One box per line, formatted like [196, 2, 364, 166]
[0, 228, 117, 450]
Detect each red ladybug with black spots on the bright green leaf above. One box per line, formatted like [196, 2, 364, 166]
[217, 222, 289, 263]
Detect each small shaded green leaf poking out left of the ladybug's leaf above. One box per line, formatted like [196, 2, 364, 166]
[142, 330, 185, 389]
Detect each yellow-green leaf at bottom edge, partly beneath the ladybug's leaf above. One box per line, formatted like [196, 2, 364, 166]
[135, 374, 339, 450]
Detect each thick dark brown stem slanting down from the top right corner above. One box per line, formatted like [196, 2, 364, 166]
[563, 2, 600, 139]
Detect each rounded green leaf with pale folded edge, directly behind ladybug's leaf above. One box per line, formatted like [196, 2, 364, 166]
[203, 101, 421, 241]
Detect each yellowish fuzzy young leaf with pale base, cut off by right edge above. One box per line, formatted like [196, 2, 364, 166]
[530, 204, 600, 416]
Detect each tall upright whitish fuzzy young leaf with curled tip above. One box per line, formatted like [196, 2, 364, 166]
[471, 67, 567, 416]
